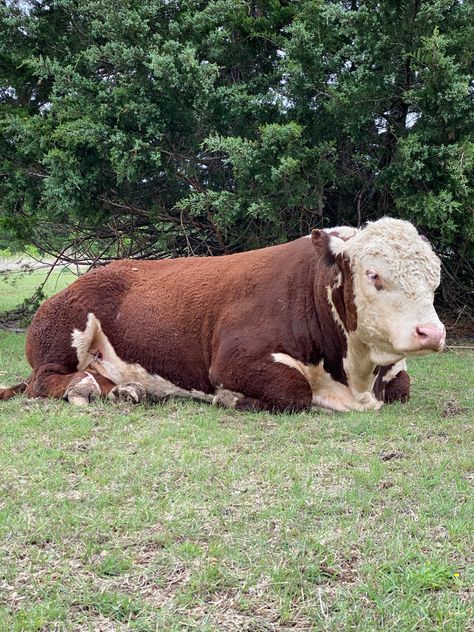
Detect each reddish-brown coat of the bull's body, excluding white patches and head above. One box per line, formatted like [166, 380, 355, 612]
[26, 238, 350, 410]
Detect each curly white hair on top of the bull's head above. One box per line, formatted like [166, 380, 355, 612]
[330, 217, 441, 294]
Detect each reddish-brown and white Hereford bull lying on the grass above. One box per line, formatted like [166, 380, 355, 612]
[0, 218, 445, 411]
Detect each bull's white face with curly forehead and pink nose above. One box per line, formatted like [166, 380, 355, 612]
[330, 218, 445, 364]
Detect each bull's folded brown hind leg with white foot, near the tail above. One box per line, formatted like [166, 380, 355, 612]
[25, 364, 115, 405]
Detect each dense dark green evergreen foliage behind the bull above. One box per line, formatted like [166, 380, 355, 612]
[0, 0, 474, 304]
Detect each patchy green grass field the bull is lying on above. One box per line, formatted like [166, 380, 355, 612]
[0, 273, 474, 632]
